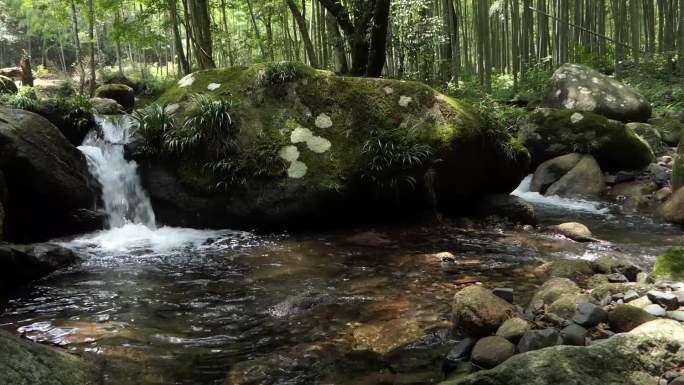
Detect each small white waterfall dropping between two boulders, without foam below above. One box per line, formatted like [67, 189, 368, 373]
[78, 116, 156, 229]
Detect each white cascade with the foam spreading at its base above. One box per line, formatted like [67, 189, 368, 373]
[70, 116, 235, 254]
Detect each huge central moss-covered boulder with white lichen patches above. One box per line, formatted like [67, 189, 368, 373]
[136, 63, 529, 227]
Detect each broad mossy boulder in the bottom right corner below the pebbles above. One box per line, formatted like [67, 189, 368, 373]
[441, 320, 684, 385]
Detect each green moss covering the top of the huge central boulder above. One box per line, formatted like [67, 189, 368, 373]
[158, 63, 527, 196]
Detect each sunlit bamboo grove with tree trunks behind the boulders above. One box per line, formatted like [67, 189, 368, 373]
[0, 0, 684, 89]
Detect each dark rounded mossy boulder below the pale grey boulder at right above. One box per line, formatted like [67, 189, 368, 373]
[518, 108, 655, 171]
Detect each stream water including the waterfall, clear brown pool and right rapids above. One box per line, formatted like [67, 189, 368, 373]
[0, 118, 683, 385]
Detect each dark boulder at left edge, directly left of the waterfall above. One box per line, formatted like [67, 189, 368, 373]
[0, 108, 99, 242]
